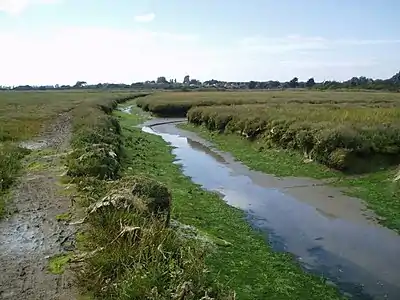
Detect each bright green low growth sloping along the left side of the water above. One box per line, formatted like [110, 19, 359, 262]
[114, 109, 341, 300]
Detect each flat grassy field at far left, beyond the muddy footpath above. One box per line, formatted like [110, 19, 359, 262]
[0, 91, 141, 217]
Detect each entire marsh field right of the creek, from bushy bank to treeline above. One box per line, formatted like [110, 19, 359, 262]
[138, 91, 400, 173]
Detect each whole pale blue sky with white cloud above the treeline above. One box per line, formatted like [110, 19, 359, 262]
[0, 0, 400, 85]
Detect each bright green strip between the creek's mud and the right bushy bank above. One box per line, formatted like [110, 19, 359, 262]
[181, 124, 400, 231]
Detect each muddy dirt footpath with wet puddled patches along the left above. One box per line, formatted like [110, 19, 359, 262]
[0, 114, 76, 300]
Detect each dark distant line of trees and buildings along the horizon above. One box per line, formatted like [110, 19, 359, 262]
[0, 72, 400, 91]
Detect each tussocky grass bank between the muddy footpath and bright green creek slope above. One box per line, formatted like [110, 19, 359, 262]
[66, 99, 232, 299]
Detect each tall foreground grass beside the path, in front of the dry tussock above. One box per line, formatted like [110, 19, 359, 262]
[79, 198, 228, 300]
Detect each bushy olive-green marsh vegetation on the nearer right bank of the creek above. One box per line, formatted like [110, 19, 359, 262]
[188, 103, 400, 173]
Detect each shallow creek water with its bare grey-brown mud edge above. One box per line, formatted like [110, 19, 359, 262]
[143, 119, 400, 299]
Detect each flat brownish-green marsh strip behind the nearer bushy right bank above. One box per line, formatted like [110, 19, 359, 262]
[138, 91, 400, 117]
